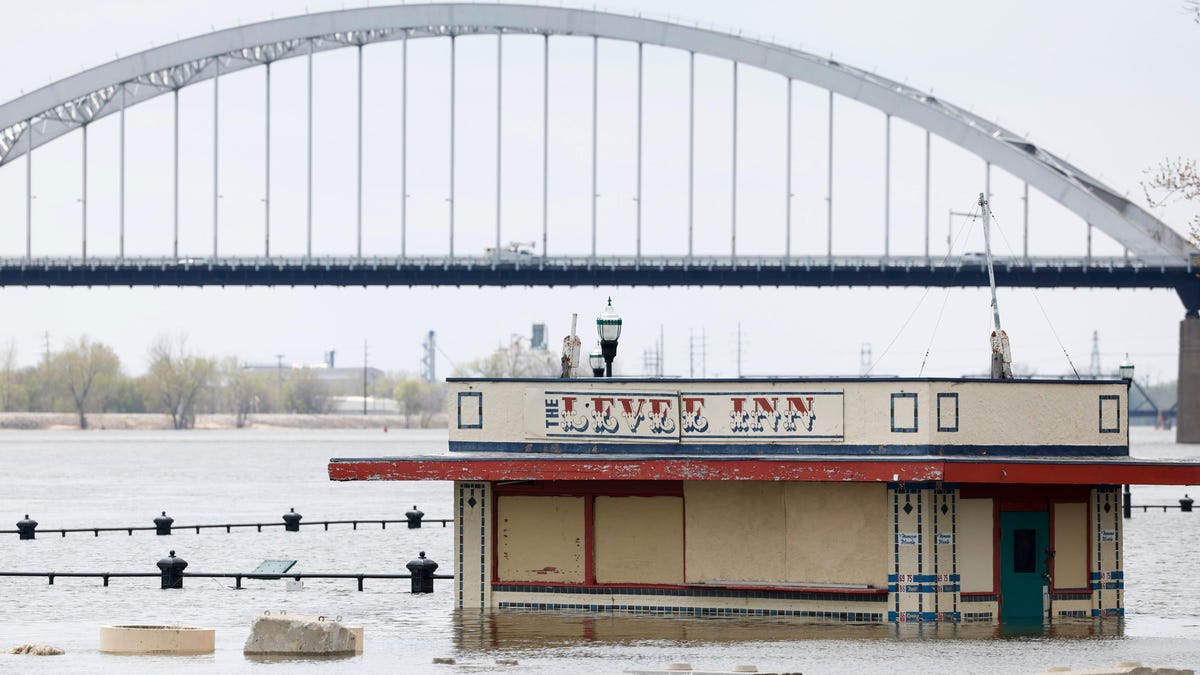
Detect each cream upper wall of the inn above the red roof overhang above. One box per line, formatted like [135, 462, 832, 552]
[450, 380, 1128, 454]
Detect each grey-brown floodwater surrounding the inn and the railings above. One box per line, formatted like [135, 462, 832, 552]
[0, 429, 1200, 675]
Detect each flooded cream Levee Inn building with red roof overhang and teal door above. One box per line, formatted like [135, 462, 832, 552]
[329, 378, 1200, 622]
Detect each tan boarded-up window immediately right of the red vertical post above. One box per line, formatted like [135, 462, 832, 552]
[594, 497, 683, 584]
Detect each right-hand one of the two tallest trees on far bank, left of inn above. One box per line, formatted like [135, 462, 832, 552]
[145, 336, 216, 429]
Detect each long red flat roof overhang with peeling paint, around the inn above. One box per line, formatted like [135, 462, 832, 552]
[329, 454, 1200, 485]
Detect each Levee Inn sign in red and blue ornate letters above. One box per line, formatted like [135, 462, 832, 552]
[524, 389, 844, 442]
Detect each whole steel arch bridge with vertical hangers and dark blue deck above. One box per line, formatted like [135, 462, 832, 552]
[0, 4, 1200, 305]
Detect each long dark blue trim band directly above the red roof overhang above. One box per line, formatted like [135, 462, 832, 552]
[450, 441, 1129, 454]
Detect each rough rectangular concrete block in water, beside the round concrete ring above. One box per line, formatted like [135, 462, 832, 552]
[242, 614, 361, 655]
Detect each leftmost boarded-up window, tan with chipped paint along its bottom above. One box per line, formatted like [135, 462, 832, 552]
[496, 496, 586, 583]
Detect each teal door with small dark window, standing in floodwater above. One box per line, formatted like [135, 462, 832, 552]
[1000, 512, 1050, 621]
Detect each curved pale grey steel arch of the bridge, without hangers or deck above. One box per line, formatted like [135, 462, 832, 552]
[0, 4, 1196, 260]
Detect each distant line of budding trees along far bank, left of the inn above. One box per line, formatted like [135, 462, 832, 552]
[0, 335, 445, 429]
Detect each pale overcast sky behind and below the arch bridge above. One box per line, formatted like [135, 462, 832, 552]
[0, 0, 1200, 381]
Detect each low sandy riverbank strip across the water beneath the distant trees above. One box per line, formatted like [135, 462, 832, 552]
[0, 412, 446, 431]
